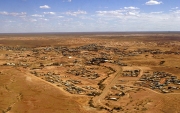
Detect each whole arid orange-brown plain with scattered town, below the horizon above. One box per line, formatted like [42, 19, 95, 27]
[0, 32, 180, 113]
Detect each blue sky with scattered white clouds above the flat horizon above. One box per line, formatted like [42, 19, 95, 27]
[0, 0, 180, 33]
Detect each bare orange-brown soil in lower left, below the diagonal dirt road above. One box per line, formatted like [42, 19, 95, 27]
[0, 66, 93, 113]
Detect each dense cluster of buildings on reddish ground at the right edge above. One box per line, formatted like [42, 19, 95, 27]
[139, 71, 180, 93]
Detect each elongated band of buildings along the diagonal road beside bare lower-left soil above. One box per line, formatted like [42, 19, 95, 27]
[31, 71, 100, 96]
